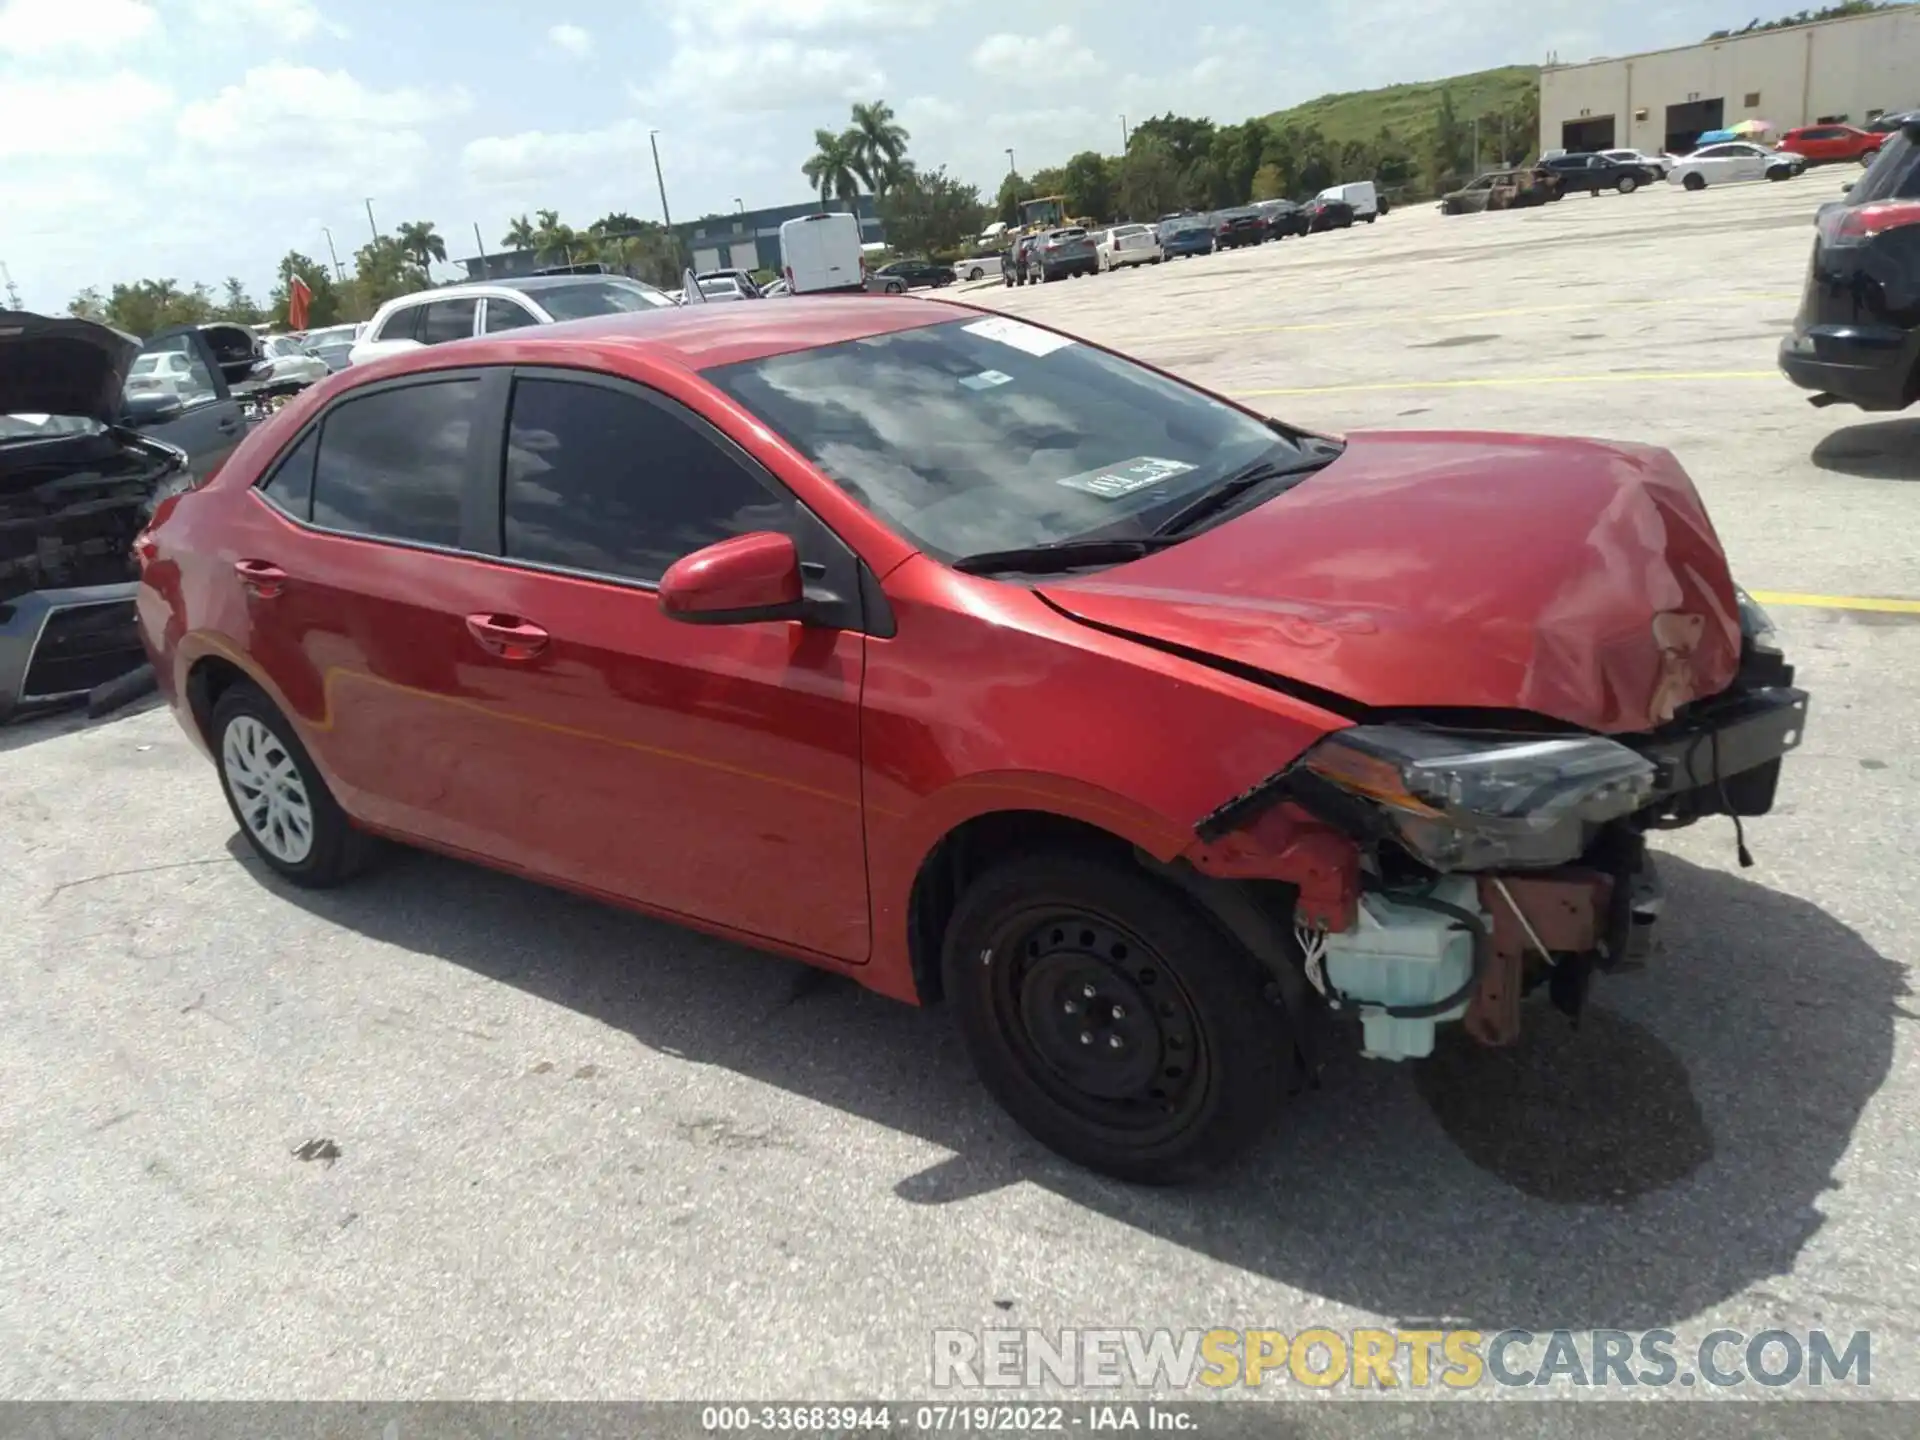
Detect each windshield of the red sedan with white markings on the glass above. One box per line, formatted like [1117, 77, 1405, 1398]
[707, 317, 1306, 561]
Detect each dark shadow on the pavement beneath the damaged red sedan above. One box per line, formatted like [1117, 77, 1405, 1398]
[232, 835, 1907, 1331]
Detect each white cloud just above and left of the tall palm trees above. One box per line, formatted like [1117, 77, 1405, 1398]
[632, 40, 887, 115]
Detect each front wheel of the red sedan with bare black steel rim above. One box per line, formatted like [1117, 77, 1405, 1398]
[943, 851, 1294, 1185]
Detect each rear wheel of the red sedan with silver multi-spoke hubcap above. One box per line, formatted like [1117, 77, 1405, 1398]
[209, 682, 378, 889]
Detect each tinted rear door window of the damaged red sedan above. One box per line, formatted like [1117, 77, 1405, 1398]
[313, 380, 480, 545]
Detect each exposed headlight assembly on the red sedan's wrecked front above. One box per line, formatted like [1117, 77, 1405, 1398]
[1300, 726, 1655, 870]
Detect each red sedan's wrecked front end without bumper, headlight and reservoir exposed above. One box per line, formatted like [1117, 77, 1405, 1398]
[1187, 593, 1807, 1060]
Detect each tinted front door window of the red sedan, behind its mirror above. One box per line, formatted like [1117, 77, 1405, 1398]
[503, 380, 793, 580]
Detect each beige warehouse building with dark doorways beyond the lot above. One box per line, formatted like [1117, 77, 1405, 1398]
[1540, 6, 1920, 154]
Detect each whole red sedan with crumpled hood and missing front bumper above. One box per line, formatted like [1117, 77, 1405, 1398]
[136, 298, 1807, 1181]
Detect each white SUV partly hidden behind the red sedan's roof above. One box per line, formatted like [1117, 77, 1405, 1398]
[348, 275, 674, 365]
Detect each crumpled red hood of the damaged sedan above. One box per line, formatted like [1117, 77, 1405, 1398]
[1041, 432, 1740, 733]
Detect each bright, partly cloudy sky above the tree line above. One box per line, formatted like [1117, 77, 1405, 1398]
[0, 0, 1758, 311]
